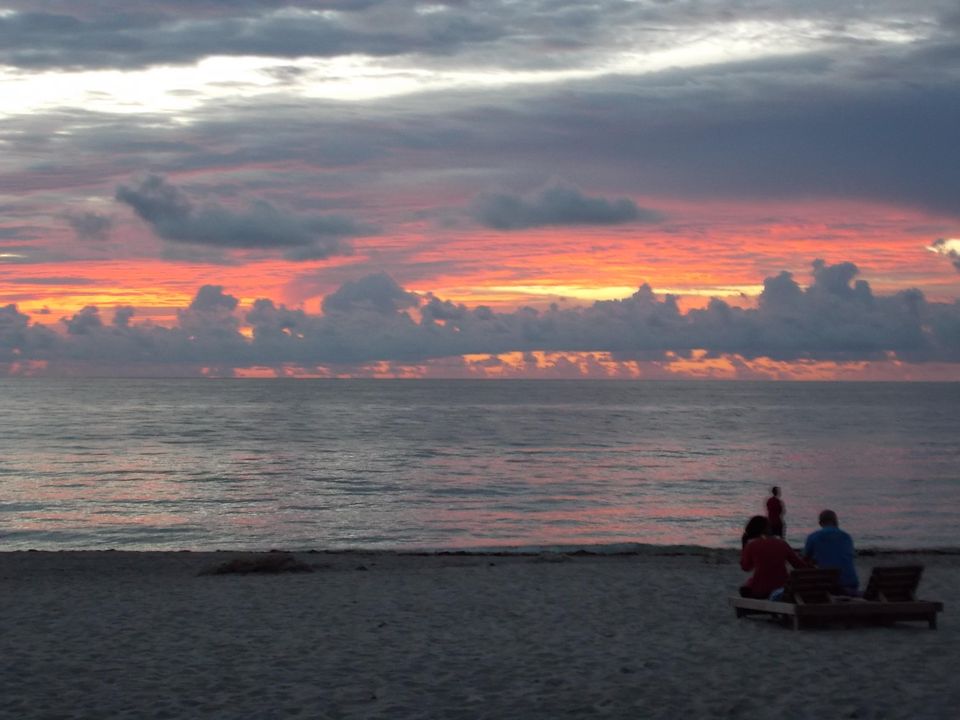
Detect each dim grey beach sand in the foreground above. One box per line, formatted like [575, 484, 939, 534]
[0, 548, 960, 720]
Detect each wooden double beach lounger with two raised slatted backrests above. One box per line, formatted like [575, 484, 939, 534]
[730, 566, 943, 630]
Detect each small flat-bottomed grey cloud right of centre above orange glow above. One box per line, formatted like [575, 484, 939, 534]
[473, 185, 660, 230]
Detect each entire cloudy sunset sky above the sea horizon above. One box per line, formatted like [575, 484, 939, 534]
[0, 0, 960, 380]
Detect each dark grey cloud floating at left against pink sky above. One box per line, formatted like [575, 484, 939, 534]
[116, 175, 372, 259]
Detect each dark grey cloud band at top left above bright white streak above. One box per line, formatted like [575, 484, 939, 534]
[0, 3, 504, 69]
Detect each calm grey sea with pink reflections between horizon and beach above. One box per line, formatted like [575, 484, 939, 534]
[0, 379, 960, 549]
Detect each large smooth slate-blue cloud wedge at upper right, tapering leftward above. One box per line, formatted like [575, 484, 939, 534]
[430, 56, 960, 216]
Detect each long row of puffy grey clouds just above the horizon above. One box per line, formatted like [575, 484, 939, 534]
[0, 260, 960, 374]
